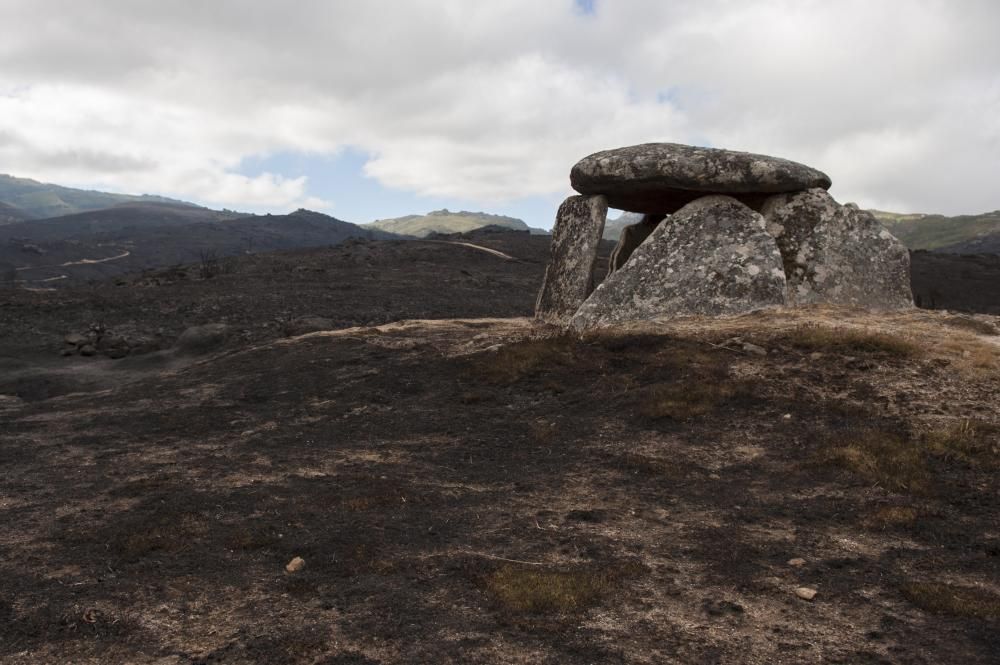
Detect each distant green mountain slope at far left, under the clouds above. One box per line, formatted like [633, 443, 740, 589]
[0, 174, 192, 219]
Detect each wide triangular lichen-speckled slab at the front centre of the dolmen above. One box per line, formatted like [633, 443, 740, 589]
[570, 196, 785, 331]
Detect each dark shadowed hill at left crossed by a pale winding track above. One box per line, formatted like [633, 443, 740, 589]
[0, 202, 392, 286]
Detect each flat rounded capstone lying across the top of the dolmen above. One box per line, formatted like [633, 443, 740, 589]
[570, 143, 830, 215]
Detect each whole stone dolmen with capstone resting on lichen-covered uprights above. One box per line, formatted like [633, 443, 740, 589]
[535, 143, 913, 331]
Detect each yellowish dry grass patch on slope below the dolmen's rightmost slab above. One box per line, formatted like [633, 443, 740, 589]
[818, 429, 930, 493]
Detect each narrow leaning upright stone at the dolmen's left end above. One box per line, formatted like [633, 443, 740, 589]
[535, 196, 608, 323]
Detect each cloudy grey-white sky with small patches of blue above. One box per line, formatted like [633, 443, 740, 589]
[0, 0, 1000, 227]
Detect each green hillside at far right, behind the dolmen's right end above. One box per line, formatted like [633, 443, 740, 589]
[871, 210, 1000, 251]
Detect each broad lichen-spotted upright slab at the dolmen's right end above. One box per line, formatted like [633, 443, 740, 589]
[763, 189, 913, 309]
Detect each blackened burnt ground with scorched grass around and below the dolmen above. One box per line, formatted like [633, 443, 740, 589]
[0, 230, 1000, 664]
